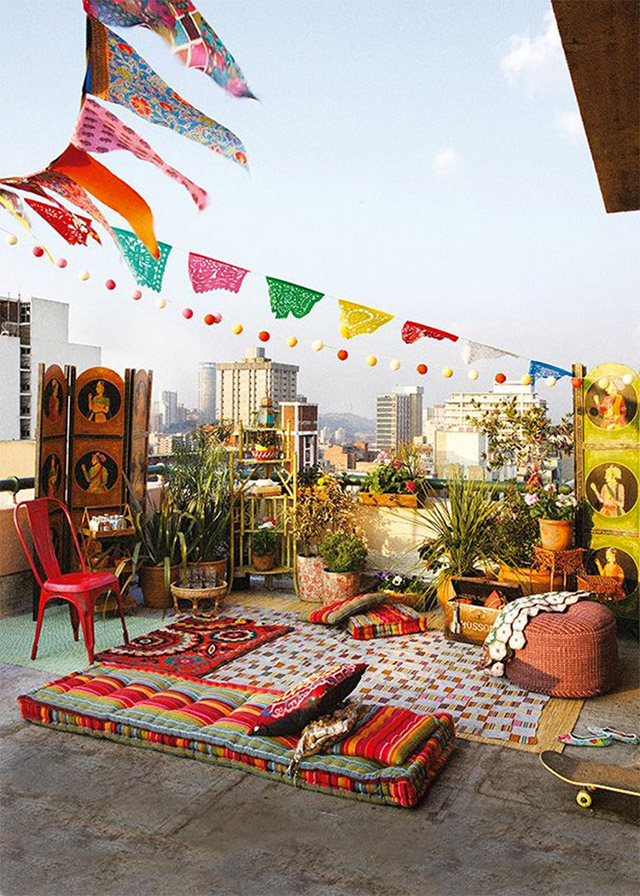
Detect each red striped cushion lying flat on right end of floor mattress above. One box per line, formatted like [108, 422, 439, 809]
[332, 706, 438, 765]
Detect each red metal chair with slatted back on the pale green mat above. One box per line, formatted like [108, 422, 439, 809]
[13, 498, 129, 663]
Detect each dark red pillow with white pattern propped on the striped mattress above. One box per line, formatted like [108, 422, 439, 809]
[252, 663, 367, 737]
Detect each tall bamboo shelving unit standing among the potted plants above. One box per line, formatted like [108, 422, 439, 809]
[229, 424, 298, 590]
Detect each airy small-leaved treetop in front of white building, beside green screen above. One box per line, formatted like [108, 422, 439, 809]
[469, 397, 573, 471]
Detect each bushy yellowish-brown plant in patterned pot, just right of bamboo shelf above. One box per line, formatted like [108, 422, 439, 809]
[290, 471, 357, 601]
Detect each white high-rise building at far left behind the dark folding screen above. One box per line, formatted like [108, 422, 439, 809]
[0, 296, 102, 441]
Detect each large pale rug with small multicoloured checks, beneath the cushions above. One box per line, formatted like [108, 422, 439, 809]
[212, 607, 581, 749]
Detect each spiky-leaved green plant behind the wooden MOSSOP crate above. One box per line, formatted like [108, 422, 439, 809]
[418, 479, 499, 609]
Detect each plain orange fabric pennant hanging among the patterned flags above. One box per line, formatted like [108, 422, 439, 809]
[49, 144, 160, 258]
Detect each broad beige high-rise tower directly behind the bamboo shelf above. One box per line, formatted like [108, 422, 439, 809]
[216, 347, 300, 426]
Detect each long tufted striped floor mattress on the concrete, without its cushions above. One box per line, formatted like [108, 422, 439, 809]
[18, 665, 455, 807]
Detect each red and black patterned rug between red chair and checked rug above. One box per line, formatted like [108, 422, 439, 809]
[95, 616, 291, 678]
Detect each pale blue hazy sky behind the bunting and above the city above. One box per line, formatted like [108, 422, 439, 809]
[0, 0, 640, 417]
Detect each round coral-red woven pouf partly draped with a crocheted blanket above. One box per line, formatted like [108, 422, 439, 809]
[506, 601, 618, 697]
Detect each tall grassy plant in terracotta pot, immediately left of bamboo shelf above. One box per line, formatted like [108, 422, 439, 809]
[165, 429, 230, 582]
